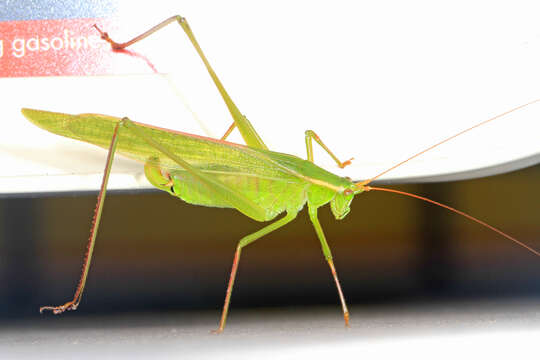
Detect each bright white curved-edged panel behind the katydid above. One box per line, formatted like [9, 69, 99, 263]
[0, 1, 540, 194]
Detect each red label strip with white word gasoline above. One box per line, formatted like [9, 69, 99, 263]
[0, 18, 151, 77]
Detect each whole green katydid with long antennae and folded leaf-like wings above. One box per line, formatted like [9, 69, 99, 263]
[22, 16, 540, 332]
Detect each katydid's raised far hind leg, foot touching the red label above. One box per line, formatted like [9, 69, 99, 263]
[94, 15, 268, 149]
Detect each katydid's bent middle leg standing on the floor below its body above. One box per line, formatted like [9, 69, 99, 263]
[213, 212, 297, 334]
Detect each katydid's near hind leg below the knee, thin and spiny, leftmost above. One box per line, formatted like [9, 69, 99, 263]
[39, 123, 120, 314]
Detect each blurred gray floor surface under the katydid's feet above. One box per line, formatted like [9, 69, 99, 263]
[0, 300, 540, 359]
